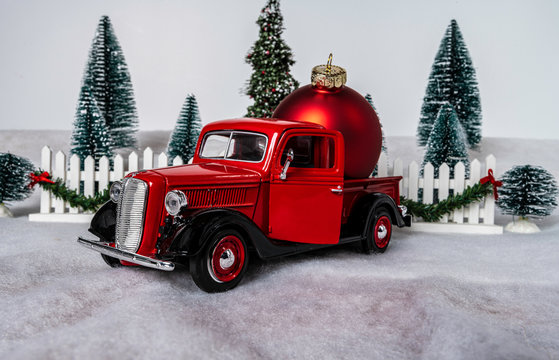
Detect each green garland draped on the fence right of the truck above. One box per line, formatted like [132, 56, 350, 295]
[400, 182, 493, 222]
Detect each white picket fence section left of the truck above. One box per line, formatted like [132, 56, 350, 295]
[29, 146, 183, 222]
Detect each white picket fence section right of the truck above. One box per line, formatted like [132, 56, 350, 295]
[378, 153, 503, 234]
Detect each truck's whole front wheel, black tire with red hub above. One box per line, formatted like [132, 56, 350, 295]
[190, 229, 248, 293]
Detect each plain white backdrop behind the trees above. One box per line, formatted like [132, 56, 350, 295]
[0, 0, 559, 138]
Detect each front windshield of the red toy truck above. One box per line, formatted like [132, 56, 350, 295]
[200, 131, 268, 162]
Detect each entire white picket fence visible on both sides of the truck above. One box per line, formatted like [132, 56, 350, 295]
[29, 146, 503, 234]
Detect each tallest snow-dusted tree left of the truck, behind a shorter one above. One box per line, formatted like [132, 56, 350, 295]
[83, 16, 138, 149]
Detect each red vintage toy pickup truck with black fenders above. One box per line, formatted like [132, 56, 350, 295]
[78, 119, 411, 292]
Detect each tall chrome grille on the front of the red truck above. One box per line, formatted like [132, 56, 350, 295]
[116, 178, 148, 252]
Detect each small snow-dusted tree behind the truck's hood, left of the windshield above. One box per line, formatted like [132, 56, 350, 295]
[167, 95, 202, 165]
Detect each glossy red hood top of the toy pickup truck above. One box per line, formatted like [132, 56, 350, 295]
[150, 163, 261, 187]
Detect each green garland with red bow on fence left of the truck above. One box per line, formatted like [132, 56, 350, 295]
[34, 171, 109, 211]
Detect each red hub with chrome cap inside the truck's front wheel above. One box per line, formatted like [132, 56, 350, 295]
[210, 235, 245, 282]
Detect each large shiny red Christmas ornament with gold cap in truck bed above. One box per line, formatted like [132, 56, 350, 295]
[272, 56, 382, 178]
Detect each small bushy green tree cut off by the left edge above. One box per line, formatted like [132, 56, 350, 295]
[0, 153, 35, 205]
